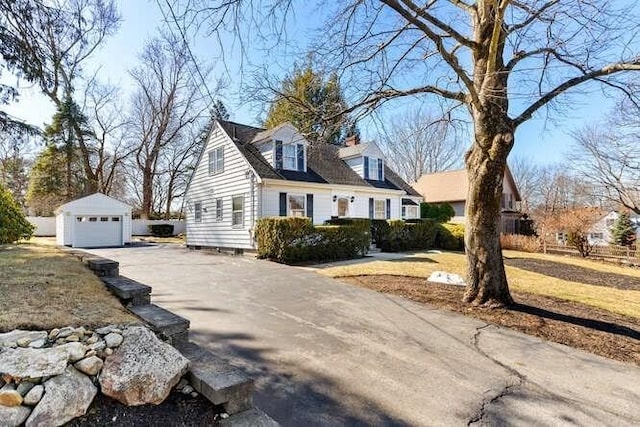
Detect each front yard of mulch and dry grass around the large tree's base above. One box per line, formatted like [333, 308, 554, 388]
[320, 251, 640, 365]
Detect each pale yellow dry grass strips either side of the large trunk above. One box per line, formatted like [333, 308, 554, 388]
[319, 253, 640, 318]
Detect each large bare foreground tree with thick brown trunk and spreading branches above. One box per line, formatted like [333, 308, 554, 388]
[179, 0, 640, 306]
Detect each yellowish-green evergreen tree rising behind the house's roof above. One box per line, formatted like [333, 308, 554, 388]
[264, 64, 350, 144]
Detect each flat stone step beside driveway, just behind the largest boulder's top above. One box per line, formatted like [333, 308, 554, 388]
[129, 304, 190, 347]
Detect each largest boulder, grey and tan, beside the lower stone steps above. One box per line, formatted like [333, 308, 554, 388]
[100, 326, 189, 406]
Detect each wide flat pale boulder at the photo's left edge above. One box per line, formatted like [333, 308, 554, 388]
[0, 347, 69, 378]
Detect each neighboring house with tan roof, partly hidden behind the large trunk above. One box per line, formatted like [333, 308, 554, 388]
[412, 167, 521, 233]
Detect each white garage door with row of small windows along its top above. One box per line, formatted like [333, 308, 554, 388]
[73, 216, 122, 248]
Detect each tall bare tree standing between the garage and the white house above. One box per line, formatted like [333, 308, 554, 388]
[129, 33, 207, 218]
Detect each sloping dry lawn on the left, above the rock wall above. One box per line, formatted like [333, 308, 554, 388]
[0, 243, 138, 332]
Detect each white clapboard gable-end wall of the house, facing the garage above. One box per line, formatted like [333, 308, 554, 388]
[186, 125, 259, 249]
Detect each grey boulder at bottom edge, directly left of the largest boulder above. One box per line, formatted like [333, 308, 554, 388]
[25, 366, 98, 427]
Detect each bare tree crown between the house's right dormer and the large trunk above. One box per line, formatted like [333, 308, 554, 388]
[380, 109, 466, 182]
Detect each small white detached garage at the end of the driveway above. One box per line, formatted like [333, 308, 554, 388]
[55, 193, 131, 248]
